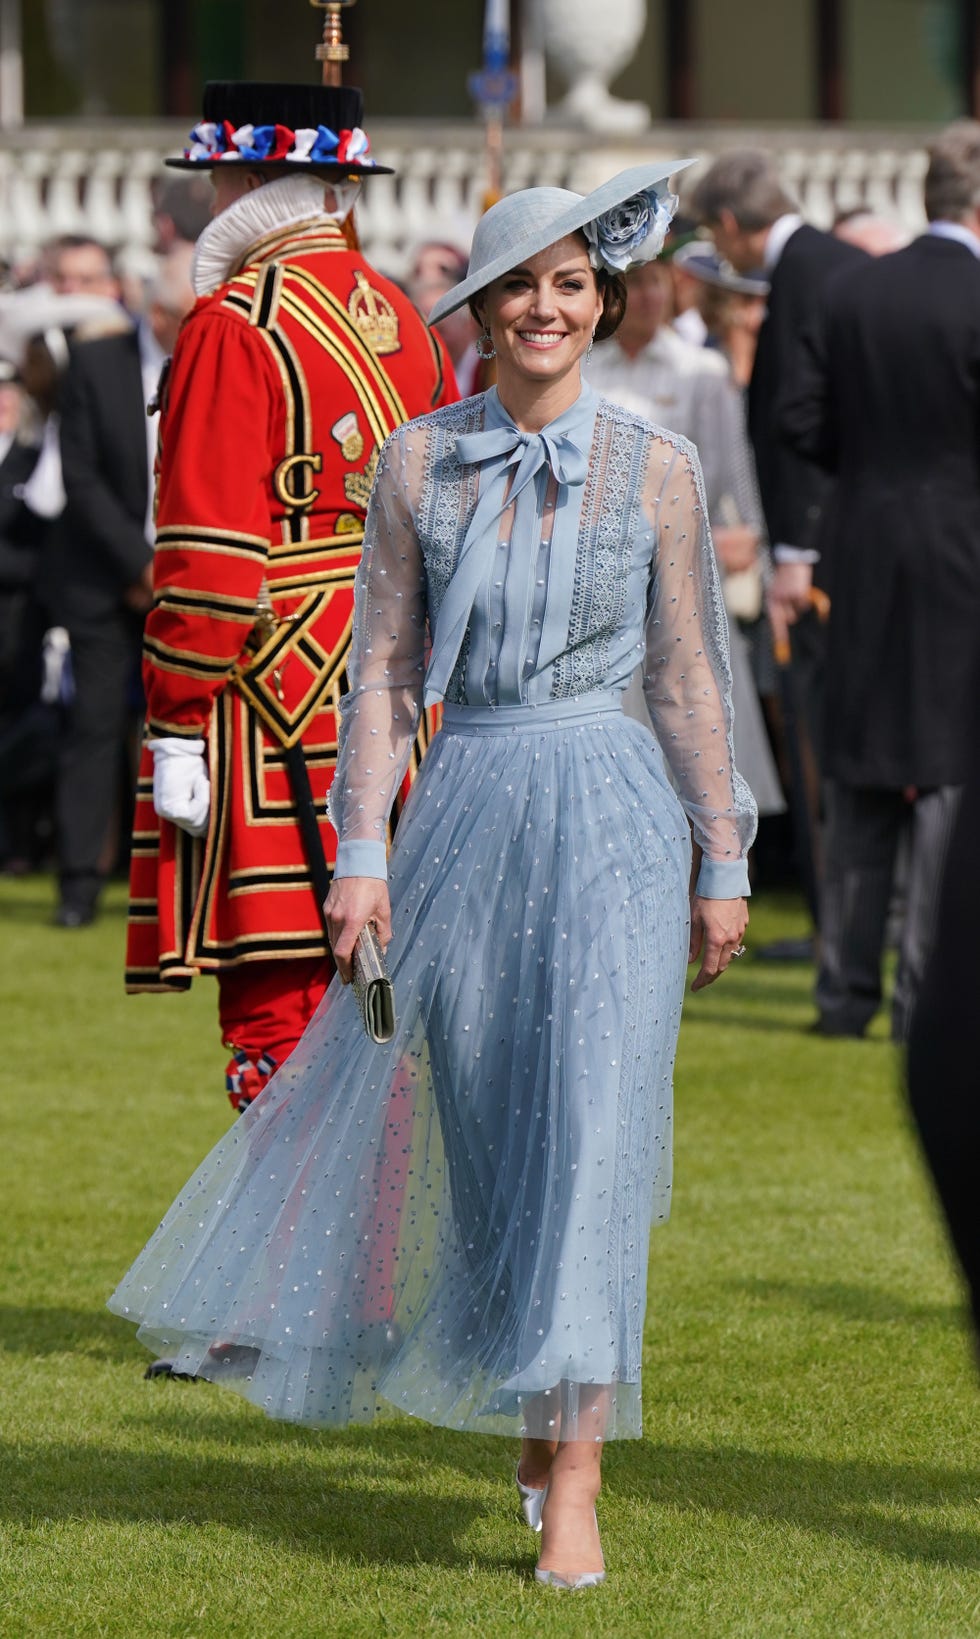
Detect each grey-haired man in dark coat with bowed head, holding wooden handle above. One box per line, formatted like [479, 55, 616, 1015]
[690, 158, 867, 956]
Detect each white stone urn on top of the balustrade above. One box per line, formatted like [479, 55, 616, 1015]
[529, 0, 651, 134]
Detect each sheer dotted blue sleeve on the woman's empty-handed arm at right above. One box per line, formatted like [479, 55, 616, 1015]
[644, 439, 755, 898]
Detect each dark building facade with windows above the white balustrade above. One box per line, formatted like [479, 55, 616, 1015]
[11, 0, 980, 126]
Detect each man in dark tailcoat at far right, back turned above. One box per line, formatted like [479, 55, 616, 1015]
[780, 121, 980, 1039]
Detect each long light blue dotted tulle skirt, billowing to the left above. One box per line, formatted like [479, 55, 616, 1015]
[110, 701, 690, 1439]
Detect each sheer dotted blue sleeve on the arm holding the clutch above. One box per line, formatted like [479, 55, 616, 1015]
[328, 428, 426, 877]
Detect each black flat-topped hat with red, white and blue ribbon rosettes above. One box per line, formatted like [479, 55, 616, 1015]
[166, 80, 392, 179]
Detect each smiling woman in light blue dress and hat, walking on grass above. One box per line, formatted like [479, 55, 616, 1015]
[113, 166, 754, 1588]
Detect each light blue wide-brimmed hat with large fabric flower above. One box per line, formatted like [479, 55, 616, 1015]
[429, 159, 695, 325]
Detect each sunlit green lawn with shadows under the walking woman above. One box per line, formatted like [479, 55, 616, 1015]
[0, 880, 980, 1639]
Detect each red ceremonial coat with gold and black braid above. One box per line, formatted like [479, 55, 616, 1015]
[126, 218, 457, 1088]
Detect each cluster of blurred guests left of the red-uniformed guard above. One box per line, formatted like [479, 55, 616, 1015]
[0, 179, 210, 928]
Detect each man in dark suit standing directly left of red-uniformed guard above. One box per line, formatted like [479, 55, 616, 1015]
[46, 249, 193, 928]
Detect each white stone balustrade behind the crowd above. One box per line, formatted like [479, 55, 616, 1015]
[0, 121, 926, 275]
